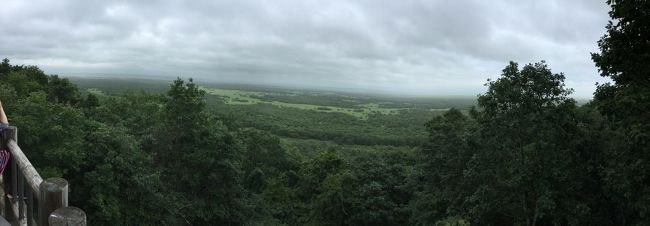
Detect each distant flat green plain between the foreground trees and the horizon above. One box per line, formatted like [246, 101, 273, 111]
[70, 77, 476, 147]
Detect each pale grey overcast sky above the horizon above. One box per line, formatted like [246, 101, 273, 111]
[0, 0, 608, 97]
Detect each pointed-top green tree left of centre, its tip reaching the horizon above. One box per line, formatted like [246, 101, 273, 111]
[151, 79, 247, 225]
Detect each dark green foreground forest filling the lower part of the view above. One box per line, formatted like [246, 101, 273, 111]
[0, 1, 650, 225]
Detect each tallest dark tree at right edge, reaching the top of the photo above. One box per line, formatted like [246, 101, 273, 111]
[592, 0, 650, 225]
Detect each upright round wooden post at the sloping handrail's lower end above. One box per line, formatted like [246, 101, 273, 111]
[38, 178, 68, 226]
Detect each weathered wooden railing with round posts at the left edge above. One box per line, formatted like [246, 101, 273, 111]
[0, 127, 86, 226]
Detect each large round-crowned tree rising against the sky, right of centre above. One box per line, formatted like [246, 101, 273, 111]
[467, 62, 576, 225]
